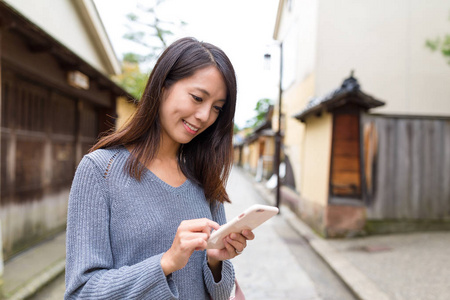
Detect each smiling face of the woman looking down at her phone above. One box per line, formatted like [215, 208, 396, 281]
[159, 66, 227, 146]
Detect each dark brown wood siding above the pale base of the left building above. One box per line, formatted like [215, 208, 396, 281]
[1, 72, 80, 205]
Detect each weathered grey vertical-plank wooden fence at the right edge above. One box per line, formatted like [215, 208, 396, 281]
[361, 115, 450, 220]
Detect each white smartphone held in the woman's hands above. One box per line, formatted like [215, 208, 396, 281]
[207, 204, 278, 249]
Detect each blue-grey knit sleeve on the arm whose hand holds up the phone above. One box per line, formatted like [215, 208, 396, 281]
[203, 202, 234, 300]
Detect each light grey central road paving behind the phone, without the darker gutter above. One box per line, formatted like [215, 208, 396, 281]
[225, 169, 320, 300]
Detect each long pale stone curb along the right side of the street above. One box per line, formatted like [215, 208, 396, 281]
[250, 176, 390, 300]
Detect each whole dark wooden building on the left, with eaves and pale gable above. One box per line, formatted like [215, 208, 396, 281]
[0, 1, 132, 260]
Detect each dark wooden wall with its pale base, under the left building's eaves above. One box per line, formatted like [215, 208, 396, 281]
[0, 69, 99, 259]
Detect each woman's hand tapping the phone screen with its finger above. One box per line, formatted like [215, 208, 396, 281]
[161, 218, 220, 276]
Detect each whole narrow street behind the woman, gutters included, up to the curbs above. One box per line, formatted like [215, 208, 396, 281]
[30, 168, 355, 300]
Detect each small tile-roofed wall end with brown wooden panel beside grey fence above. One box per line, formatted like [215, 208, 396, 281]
[294, 74, 384, 236]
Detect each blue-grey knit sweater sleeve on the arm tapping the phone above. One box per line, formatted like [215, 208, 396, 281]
[65, 157, 178, 299]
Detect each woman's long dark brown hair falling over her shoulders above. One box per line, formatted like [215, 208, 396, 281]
[91, 38, 237, 202]
